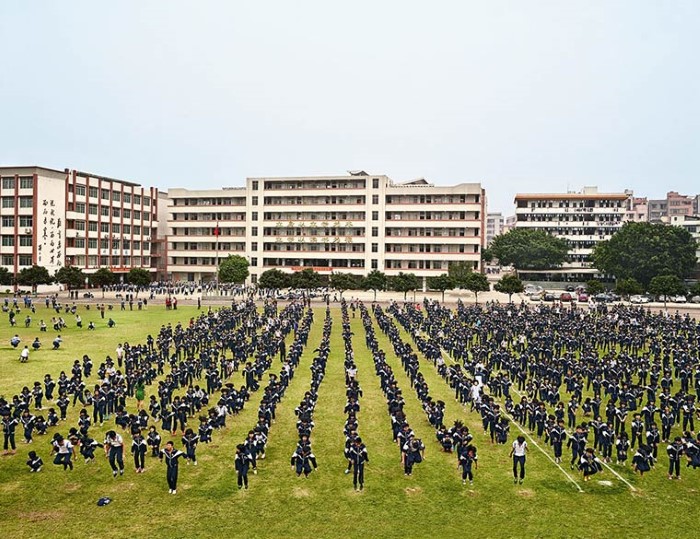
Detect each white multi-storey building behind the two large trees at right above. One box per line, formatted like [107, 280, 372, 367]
[515, 187, 632, 281]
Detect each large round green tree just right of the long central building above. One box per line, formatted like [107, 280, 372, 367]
[482, 228, 569, 271]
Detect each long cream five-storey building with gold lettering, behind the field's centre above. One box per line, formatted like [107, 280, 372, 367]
[167, 171, 486, 282]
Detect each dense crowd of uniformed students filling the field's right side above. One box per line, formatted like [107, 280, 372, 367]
[386, 300, 700, 486]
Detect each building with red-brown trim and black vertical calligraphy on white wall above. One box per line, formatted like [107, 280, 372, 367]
[0, 166, 165, 273]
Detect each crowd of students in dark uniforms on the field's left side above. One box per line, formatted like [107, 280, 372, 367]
[0, 301, 313, 494]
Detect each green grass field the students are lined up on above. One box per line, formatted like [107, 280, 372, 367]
[0, 306, 700, 538]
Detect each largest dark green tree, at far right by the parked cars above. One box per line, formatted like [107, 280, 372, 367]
[592, 223, 697, 287]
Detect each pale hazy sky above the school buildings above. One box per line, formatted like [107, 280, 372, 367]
[0, 0, 700, 214]
